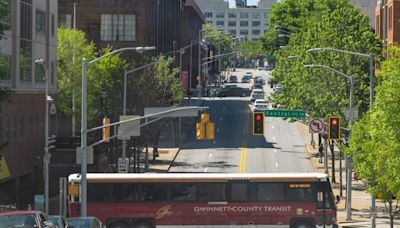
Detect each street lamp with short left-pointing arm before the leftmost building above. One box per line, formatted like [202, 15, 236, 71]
[35, 59, 53, 214]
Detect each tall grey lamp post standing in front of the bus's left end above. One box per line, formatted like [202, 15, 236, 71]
[81, 46, 156, 217]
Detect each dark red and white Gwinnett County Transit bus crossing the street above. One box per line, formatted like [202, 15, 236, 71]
[68, 173, 338, 228]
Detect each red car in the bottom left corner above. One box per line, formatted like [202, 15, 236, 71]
[0, 211, 56, 228]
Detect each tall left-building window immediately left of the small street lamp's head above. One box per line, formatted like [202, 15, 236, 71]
[19, 39, 32, 81]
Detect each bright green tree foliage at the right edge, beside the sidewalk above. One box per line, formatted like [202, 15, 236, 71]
[346, 47, 400, 224]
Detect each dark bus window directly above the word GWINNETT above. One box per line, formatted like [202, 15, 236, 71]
[197, 183, 226, 202]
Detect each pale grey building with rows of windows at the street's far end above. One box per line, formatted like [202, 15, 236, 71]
[196, 0, 277, 40]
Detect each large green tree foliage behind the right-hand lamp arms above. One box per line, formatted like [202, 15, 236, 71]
[272, 0, 380, 121]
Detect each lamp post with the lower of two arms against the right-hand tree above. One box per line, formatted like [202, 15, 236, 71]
[304, 65, 354, 220]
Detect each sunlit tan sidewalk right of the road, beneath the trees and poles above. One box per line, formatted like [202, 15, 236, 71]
[297, 122, 400, 228]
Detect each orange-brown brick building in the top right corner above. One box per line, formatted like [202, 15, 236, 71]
[375, 0, 400, 47]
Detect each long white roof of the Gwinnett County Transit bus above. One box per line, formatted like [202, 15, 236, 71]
[68, 173, 328, 182]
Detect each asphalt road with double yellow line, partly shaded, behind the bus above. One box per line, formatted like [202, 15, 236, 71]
[170, 69, 313, 173]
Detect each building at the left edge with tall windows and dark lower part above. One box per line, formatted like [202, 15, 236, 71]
[0, 0, 58, 208]
